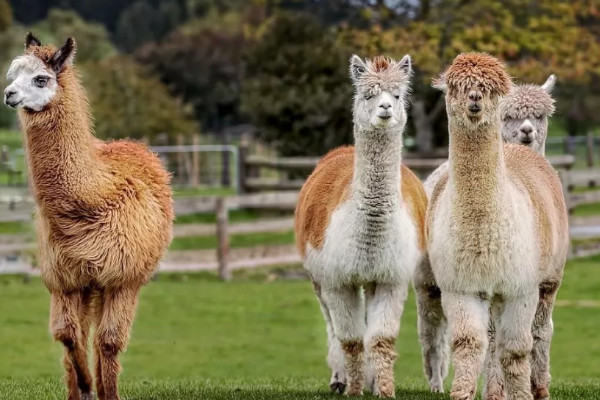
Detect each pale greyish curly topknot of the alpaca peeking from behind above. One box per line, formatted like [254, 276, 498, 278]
[500, 84, 554, 119]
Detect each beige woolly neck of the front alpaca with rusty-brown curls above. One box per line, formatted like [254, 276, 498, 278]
[449, 115, 506, 225]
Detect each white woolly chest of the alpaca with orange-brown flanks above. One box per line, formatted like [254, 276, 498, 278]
[305, 200, 421, 287]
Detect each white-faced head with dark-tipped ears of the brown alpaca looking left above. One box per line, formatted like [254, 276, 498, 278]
[4, 33, 75, 111]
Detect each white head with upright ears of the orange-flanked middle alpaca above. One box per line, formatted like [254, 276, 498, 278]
[350, 55, 412, 130]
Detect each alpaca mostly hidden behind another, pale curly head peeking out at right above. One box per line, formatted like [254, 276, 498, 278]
[414, 75, 556, 392]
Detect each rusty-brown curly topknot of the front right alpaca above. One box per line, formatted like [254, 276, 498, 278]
[445, 53, 511, 96]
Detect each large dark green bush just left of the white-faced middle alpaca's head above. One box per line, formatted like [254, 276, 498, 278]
[242, 14, 352, 156]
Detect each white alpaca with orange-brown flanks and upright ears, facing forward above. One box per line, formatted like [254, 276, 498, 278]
[295, 56, 427, 397]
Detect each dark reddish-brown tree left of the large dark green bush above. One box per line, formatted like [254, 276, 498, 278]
[136, 11, 247, 130]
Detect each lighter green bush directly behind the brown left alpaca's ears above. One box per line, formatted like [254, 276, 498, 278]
[31, 9, 115, 62]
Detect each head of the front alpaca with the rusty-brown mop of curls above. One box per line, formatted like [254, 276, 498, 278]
[433, 53, 512, 127]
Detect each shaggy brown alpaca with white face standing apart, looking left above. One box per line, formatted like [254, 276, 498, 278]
[4, 34, 173, 400]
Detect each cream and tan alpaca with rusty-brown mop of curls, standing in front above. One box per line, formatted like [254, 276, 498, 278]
[427, 53, 569, 400]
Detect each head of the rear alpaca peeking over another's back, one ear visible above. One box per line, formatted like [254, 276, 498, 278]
[500, 75, 556, 154]
